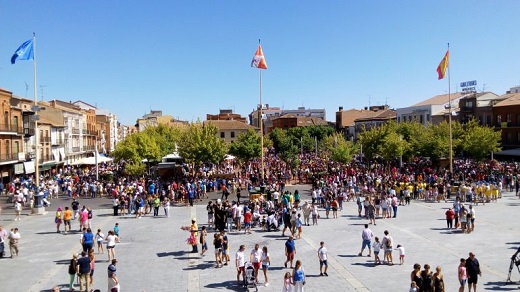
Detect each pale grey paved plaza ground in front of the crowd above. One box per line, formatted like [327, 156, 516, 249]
[0, 186, 520, 292]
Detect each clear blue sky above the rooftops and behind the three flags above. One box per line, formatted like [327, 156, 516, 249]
[0, 0, 520, 124]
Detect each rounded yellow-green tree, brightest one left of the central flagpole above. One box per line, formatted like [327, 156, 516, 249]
[179, 122, 227, 165]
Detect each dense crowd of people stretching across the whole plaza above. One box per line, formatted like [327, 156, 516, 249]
[0, 153, 520, 291]
